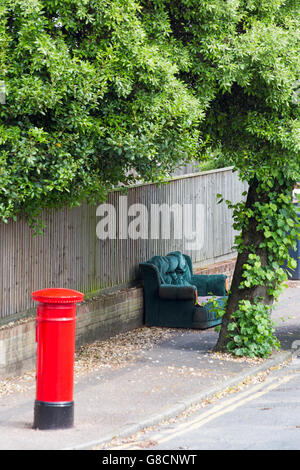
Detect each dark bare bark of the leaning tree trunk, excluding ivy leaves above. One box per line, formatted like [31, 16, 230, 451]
[215, 180, 274, 352]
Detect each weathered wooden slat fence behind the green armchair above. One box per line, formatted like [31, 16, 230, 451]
[0, 168, 245, 323]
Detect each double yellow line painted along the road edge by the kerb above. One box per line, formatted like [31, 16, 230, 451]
[113, 375, 294, 450]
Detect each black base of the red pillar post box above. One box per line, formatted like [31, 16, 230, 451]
[33, 400, 74, 429]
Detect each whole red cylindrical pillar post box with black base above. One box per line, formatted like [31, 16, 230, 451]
[32, 288, 84, 429]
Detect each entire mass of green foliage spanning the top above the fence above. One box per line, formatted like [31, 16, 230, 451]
[0, 0, 300, 220]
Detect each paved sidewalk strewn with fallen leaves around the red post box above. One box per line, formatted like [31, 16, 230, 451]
[0, 282, 300, 450]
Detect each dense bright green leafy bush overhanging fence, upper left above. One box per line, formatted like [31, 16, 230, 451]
[0, 0, 202, 221]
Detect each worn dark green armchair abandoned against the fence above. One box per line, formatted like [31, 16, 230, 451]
[140, 251, 227, 329]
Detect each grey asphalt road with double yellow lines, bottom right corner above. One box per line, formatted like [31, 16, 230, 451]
[109, 353, 300, 451]
